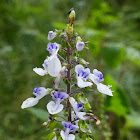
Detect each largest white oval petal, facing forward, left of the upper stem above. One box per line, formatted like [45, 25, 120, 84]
[47, 56, 61, 77]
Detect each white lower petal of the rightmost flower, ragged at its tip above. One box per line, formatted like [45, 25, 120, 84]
[97, 83, 113, 96]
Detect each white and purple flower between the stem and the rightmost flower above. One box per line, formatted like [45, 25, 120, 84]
[75, 64, 93, 88]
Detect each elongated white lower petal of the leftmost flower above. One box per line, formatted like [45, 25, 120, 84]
[21, 97, 39, 109]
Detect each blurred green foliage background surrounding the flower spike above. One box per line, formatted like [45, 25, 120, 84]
[0, 0, 140, 140]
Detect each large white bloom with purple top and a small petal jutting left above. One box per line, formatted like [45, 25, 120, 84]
[33, 43, 61, 77]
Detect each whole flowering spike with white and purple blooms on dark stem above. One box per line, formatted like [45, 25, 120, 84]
[21, 9, 113, 140]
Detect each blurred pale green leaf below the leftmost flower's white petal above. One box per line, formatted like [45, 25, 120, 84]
[28, 108, 49, 121]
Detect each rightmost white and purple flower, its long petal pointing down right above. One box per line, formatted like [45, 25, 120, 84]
[89, 69, 113, 96]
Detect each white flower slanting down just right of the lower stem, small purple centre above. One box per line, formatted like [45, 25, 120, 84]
[69, 97, 89, 120]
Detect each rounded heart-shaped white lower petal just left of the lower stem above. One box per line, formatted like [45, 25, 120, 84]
[47, 101, 63, 114]
